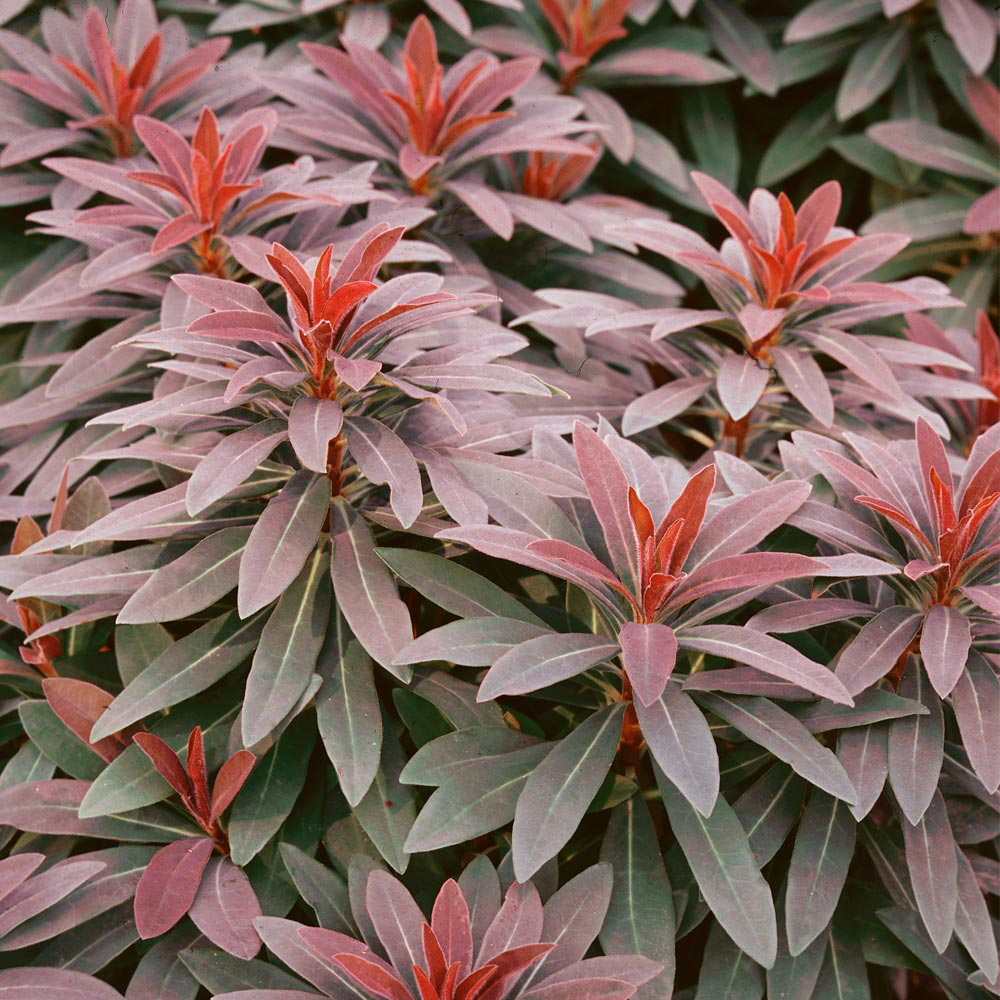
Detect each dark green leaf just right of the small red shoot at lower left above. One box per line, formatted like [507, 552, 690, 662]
[228, 716, 315, 867]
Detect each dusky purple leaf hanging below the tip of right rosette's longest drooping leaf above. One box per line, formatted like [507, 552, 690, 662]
[902, 789, 958, 954]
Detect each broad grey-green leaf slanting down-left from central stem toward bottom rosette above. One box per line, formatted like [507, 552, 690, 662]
[512, 703, 625, 882]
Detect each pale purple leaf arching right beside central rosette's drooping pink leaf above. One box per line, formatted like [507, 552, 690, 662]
[677, 625, 854, 705]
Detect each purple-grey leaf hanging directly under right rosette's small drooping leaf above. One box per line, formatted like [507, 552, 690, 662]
[889, 660, 944, 824]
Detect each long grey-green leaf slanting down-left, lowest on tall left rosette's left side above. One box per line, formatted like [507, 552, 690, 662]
[90, 611, 264, 740]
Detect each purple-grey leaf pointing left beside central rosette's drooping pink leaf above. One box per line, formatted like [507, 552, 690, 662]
[476, 632, 618, 701]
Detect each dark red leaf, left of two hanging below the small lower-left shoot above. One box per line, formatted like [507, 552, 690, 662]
[135, 837, 215, 940]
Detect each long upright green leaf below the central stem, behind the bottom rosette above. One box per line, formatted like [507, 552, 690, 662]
[601, 795, 675, 1000]
